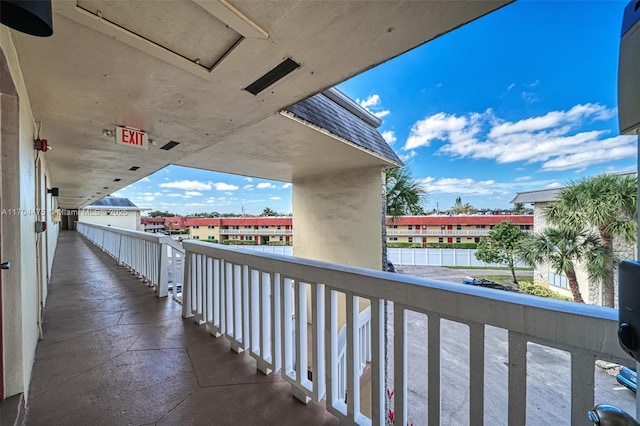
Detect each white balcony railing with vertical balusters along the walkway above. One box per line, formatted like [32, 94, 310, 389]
[78, 224, 631, 425]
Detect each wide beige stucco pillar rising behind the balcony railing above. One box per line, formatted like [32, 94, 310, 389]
[293, 167, 382, 270]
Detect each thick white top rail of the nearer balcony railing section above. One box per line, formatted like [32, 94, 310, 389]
[183, 241, 628, 360]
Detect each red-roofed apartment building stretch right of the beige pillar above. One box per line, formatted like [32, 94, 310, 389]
[387, 214, 533, 247]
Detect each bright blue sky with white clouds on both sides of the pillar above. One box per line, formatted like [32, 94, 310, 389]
[114, 0, 637, 214]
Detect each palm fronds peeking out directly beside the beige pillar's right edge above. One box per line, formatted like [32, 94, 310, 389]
[385, 166, 426, 220]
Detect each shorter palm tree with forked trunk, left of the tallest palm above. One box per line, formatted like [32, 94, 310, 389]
[518, 227, 610, 303]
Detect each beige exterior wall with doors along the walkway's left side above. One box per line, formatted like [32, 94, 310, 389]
[0, 31, 59, 397]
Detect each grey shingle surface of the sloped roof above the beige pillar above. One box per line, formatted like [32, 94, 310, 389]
[286, 93, 402, 164]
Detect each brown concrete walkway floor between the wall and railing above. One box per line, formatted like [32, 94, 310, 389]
[26, 231, 339, 426]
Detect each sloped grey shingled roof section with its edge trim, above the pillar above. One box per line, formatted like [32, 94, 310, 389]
[286, 88, 402, 165]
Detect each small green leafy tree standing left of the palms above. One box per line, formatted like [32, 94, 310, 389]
[475, 220, 526, 284]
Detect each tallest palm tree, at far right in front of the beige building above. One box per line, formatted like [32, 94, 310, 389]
[545, 175, 638, 307]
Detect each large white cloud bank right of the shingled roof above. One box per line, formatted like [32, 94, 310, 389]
[403, 104, 637, 171]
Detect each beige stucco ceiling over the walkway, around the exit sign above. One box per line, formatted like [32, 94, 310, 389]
[6, 0, 509, 208]
